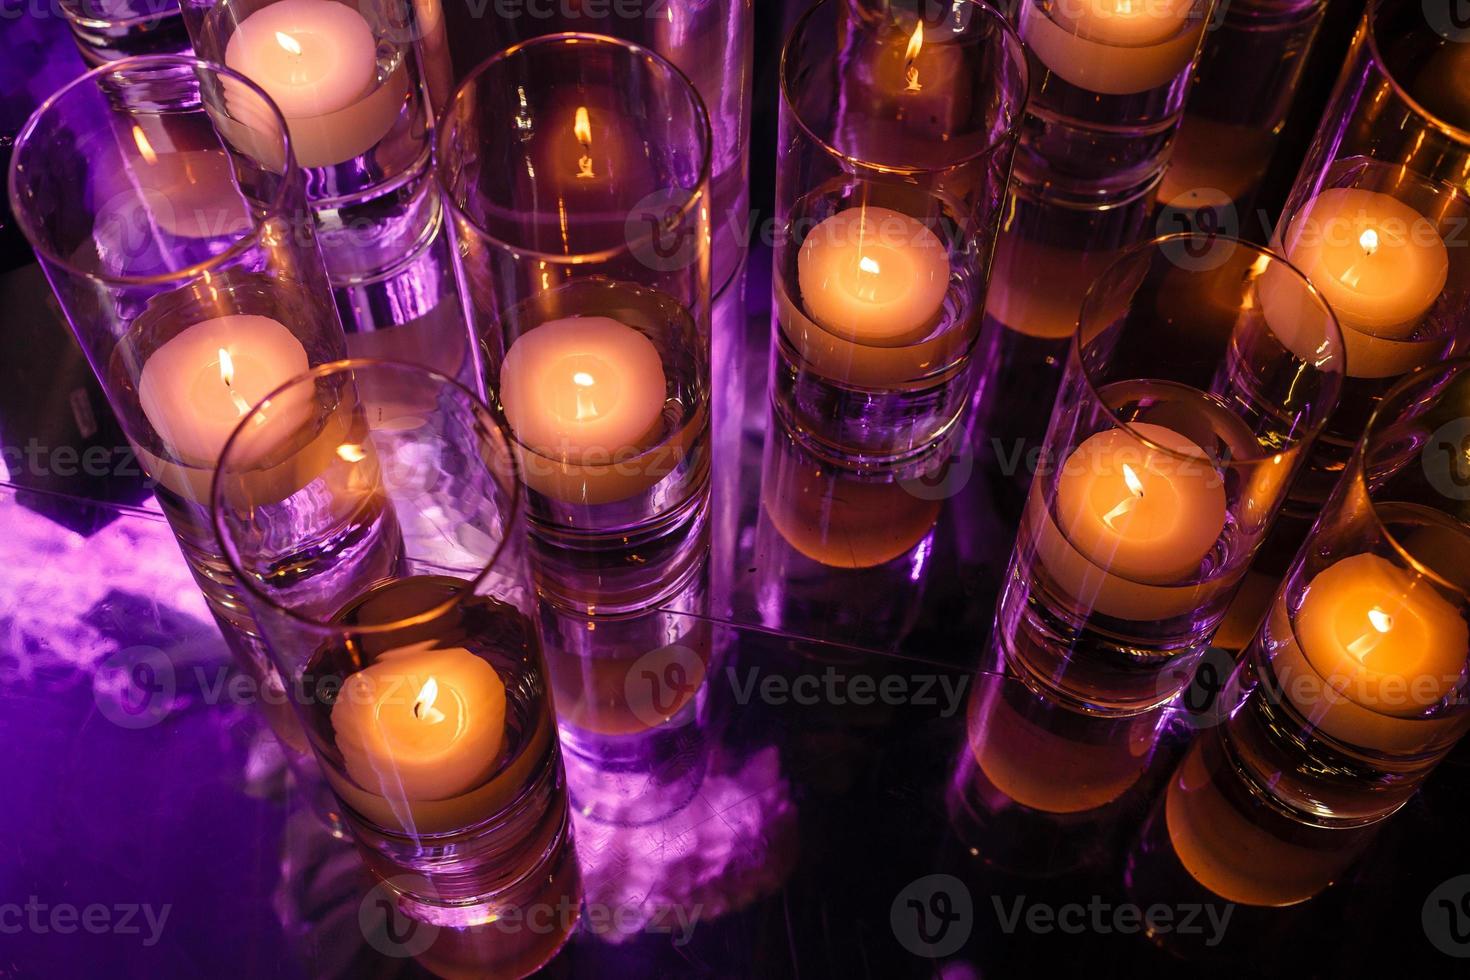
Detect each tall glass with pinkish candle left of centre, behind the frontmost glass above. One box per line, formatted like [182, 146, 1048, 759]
[437, 34, 710, 611]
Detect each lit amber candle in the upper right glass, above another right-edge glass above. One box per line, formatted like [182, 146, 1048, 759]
[1260, 188, 1449, 378]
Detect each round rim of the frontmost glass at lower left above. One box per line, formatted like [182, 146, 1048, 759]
[209, 357, 523, 636]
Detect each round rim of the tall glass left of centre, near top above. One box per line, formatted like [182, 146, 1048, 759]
[432, 31, 714, 266]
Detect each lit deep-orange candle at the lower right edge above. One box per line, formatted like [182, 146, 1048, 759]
[1288, 554, 1470, 717]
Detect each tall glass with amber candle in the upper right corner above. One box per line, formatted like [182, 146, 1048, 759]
[1260, 0, 1470, 580]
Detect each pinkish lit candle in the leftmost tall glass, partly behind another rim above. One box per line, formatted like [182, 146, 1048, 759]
[138, 314, 310, 467]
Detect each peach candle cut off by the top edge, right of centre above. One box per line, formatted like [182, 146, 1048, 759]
[1019, 0, 1204, 96]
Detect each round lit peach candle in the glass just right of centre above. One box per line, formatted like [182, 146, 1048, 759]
[797, 207, 950, 347]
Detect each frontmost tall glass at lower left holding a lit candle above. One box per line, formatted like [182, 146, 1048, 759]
[213, 360, 579, 957]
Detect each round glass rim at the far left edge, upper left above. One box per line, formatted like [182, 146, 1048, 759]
[6, 54, 300, 287]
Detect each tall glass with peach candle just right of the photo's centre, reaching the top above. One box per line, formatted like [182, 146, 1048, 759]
[772, 0, 1028, 467]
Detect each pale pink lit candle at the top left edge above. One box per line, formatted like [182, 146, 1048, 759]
[225, 0, 407, 167]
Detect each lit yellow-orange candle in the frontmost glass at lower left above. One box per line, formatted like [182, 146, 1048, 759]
[332, 644, 506, 802]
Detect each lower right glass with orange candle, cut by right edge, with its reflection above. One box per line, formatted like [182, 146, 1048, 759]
[1130, 359, 1470, 907]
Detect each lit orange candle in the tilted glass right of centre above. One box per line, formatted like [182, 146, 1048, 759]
[1057, 423, 1226, 585]
